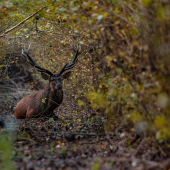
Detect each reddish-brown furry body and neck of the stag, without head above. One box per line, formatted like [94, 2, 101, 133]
[14, 83, 63, 119]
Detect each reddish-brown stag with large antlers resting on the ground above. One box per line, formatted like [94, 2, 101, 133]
[14, 45, 80, 119]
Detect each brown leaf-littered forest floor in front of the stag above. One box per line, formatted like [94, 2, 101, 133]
[0, 89, 170, 170]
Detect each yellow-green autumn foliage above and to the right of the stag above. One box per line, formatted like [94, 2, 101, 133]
[0, 0, 170, 139]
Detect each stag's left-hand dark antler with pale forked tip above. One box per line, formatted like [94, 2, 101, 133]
[22, 44, 53, 76]
